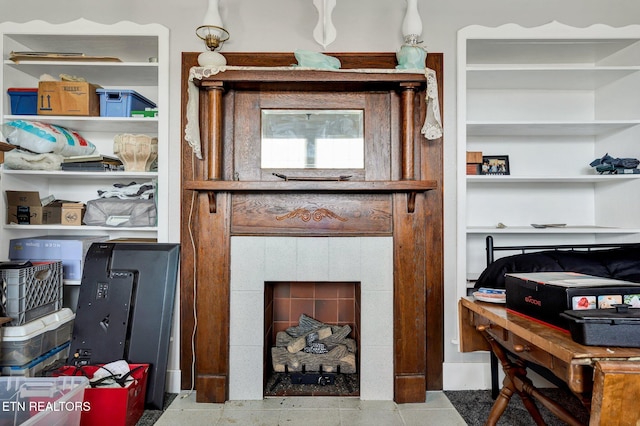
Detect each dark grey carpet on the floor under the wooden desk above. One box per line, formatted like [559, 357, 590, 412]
[444, 388, 589, 426]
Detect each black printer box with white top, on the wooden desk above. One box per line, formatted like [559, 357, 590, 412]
[505, 272, 640, 331]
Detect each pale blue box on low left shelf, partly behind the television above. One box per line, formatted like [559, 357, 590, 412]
[9, 235, 109, 281]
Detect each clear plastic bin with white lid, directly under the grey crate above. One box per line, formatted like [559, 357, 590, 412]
[0, 308, 75, 366]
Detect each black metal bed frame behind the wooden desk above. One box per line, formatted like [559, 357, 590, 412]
[485, 235, 640, 399]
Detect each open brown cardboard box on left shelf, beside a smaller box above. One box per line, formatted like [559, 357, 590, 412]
[5, 191, 62, 225]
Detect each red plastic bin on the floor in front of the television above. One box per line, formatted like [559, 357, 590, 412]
[57, 364, 149, 426]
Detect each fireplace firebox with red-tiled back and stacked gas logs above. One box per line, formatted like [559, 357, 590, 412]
[263, 281, 361, 397]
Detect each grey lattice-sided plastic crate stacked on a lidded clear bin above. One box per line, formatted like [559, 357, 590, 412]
[0, 260, 63, 326]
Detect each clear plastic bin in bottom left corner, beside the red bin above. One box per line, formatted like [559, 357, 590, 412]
[0, 377, 90, 426]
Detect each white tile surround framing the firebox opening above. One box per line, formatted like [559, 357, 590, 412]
[229, 237, 393, 401]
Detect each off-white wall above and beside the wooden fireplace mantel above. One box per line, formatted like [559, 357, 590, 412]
[0, 0, 640, 388]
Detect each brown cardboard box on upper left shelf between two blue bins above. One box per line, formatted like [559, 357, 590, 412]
[38, 81, 100, 116]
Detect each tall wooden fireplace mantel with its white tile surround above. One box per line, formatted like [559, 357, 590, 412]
[180, 53, 444, 403]
